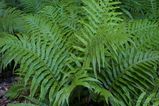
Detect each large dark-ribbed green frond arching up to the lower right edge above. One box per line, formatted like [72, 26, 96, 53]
[100, 49, 159, 105]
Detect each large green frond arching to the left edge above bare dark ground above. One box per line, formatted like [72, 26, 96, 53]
[1, 32, 68, 98]
